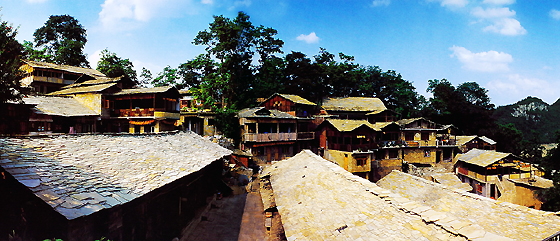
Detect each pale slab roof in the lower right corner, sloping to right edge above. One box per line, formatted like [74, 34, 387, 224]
[377, 171, 560, 240]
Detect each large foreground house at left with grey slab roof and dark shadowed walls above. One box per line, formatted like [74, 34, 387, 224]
[0, 132, 231, 241]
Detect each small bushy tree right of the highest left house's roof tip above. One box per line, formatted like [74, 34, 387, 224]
[97, 49, 138, 83]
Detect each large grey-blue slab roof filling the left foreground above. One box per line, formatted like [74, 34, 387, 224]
[0, 132, 231, 220]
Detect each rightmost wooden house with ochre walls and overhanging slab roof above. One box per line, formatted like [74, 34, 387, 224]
[454, 149, 552, 209]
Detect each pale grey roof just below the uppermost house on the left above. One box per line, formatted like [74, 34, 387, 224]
[23, 96, 99, 116]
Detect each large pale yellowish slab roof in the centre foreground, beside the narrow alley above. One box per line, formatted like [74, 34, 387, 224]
[261, 150, 470, 240]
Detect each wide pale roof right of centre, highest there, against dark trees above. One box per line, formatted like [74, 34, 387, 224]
[322, 97, 387, 112]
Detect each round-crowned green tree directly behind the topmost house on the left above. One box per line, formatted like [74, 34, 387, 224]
[28, 15, 89, 67]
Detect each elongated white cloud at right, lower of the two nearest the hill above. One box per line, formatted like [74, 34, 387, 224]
[449, 46, 513, 72]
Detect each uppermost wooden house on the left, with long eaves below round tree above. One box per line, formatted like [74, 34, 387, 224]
[20, 60, 106, 94]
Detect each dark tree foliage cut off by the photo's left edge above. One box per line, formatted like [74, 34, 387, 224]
[0, 15, 25, 105]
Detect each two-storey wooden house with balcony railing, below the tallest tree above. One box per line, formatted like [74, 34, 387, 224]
[237, 107, 315, 163]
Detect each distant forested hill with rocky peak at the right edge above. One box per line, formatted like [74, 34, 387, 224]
[493, 96, 560, 143]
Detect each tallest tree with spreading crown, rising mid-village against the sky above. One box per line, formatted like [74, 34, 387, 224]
[193, 12, 284, 108]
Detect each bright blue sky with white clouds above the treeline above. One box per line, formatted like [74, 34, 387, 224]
[0, 0, 560, 105]
